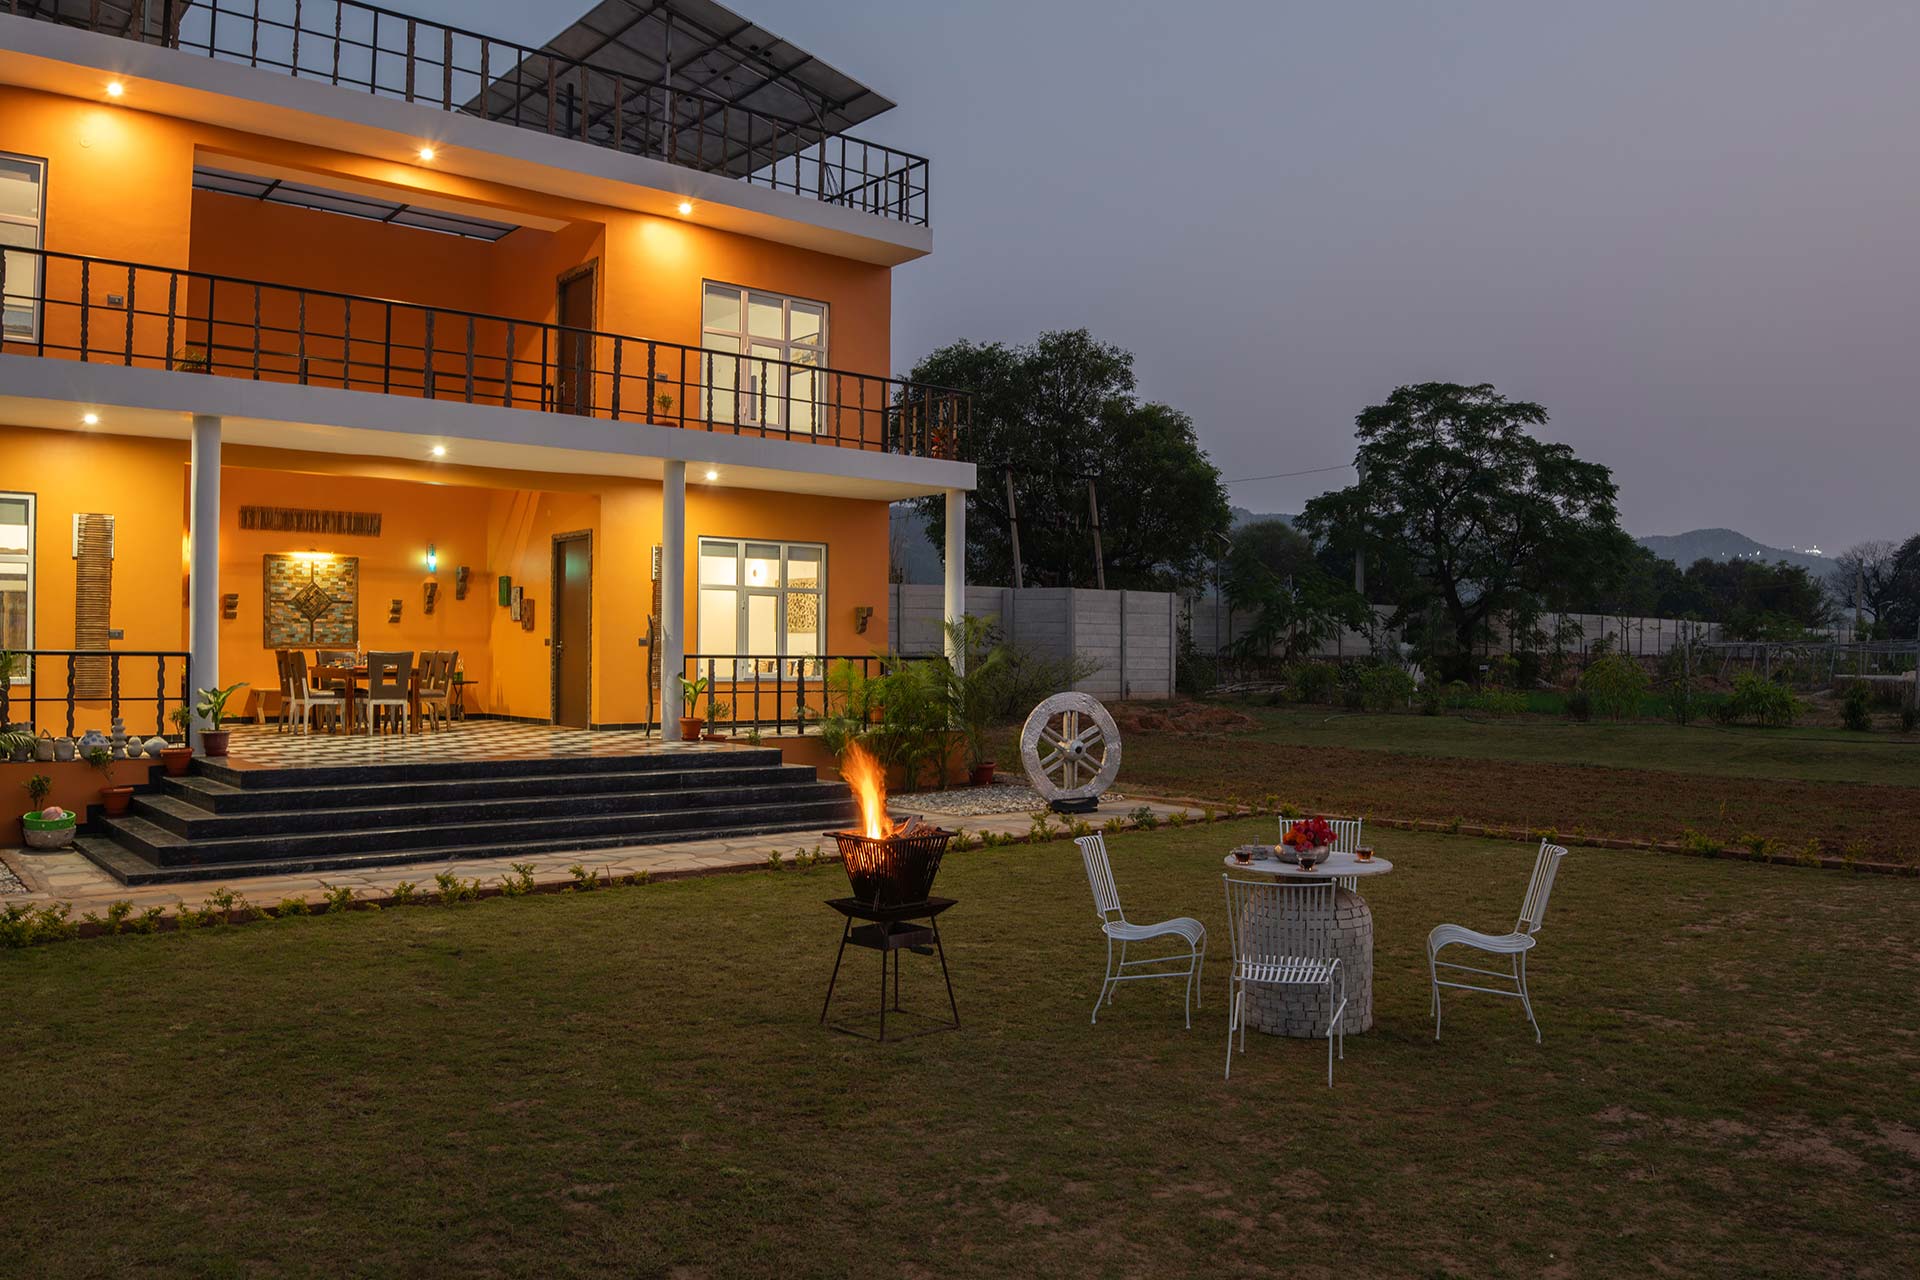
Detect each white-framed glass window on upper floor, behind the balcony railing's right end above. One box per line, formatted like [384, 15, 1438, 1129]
[699, 280, 828, 436]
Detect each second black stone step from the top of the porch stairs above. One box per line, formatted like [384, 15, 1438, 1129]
[161, 762, 816, 814]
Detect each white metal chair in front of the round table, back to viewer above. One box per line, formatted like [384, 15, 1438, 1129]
[1221, 875, 1346, 1088]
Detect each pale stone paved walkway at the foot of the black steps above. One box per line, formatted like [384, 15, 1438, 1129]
[0, 796, 1192, 915]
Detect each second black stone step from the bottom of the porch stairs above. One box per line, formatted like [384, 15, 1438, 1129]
[104, 793, 851, 865]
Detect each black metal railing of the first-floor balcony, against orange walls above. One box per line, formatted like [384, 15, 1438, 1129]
[0, 248, 972, 459]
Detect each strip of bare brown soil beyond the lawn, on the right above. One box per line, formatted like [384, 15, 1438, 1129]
[1127, 735, 1920, 867]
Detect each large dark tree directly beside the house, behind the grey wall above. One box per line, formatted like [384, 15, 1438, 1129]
[910, 330, 1233, 589]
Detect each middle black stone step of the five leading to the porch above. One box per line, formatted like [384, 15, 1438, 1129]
[132, 782, 847, 842]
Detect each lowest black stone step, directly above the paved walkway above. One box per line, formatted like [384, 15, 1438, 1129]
[73, 802, 852, 886]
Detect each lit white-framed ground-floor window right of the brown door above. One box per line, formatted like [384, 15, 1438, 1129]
[697, 537, 828, 679]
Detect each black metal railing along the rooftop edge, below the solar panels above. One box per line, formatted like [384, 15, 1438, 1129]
[0, 0, 927, 226]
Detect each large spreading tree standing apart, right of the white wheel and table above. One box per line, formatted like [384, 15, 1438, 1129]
[1300, 382, 1632, 651]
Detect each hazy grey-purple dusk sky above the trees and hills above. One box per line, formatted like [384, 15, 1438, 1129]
[453, 0, 1920, 553]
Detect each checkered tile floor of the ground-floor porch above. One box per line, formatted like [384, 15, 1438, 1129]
[227, 720, 735, 770]
